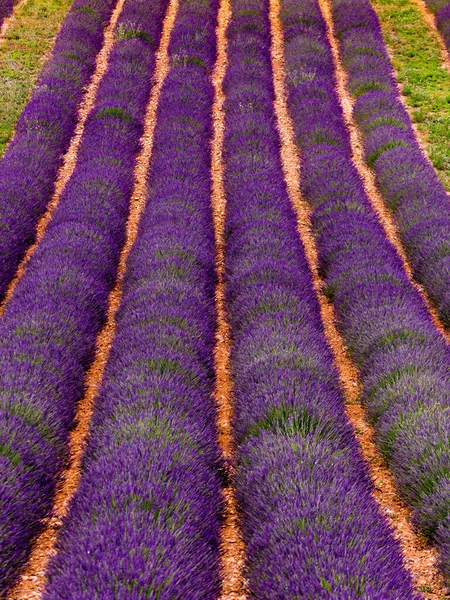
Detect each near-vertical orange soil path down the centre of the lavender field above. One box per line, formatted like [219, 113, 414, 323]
[211, 0, 246, 600]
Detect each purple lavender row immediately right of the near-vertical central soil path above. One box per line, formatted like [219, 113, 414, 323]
[224, 0, 415, 600]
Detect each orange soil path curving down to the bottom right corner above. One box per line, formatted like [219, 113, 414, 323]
[270, 0, 446, 600]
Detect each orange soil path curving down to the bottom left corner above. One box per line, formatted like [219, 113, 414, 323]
[9, 0, 178, 600]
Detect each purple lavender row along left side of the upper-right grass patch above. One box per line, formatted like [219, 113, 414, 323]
[332, 0, 450, 325]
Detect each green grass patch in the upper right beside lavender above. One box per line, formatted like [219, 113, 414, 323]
[372, 0, 450, 191]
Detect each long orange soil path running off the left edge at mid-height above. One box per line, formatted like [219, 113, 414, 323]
[0, 0, 125, 317]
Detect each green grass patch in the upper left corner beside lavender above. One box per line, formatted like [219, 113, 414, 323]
[0, 0, 72, 156]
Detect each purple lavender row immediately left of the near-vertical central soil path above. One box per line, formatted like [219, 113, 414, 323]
[40, 0, 222, 600]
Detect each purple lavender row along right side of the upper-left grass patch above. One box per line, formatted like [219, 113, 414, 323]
[0, 0, 116, 298]
